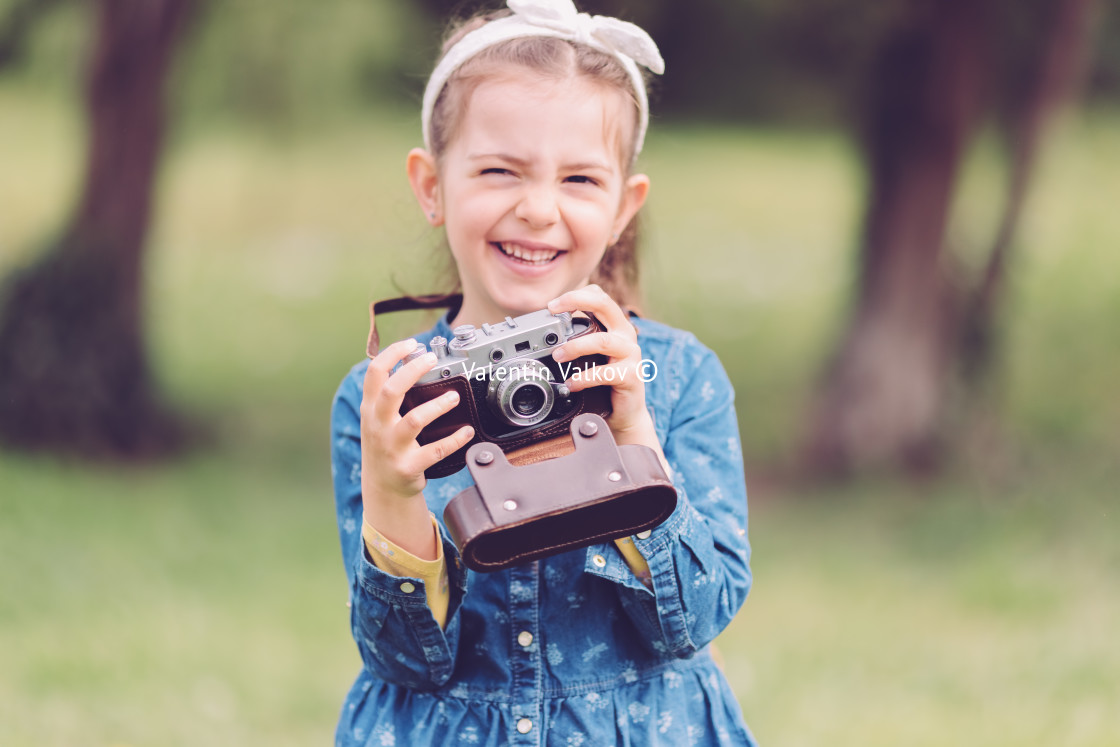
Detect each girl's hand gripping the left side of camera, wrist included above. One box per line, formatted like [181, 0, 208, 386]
[361, 339, 474, 557]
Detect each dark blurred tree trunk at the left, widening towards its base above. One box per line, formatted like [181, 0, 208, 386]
[0, 0, 195, 458]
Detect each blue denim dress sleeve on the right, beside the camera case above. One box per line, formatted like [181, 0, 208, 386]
[585, 344, 752, 657]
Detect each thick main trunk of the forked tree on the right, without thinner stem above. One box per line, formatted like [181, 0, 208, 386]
[802, 0, 990, 475]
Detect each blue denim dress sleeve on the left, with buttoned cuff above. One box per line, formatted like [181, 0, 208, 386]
[330, 363, 466, 690]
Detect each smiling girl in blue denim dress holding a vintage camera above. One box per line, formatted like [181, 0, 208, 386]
[332, 0, 754, 747]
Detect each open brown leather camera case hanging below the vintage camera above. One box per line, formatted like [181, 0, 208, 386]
[444, 413, 676, 571]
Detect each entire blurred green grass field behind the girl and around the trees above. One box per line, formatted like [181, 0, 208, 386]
[0, 84, 1120, 747]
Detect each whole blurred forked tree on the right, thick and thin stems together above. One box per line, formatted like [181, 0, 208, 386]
[803, 0, 1094, 475]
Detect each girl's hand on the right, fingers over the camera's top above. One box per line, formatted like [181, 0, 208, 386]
[549, 286, 664, 463]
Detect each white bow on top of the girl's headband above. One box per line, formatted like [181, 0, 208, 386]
[506, 0, 665, 75]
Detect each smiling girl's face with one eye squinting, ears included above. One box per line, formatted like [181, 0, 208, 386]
[409, 74, 650, 325]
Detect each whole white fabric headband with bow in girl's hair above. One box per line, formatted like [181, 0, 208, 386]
[421, 0, 665, 156]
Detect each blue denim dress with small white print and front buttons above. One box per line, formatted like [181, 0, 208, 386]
[332, 318, 755, 747]
